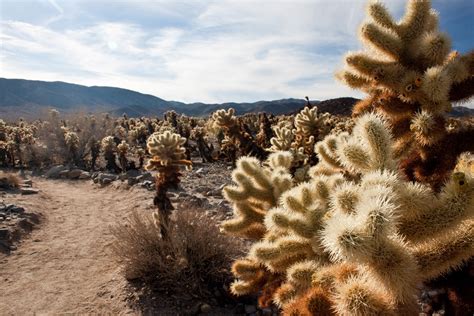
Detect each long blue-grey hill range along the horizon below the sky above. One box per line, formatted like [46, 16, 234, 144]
[0, 78, 474, 118]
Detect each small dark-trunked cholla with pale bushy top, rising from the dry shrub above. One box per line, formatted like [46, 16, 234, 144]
[145, 131, 192, 238]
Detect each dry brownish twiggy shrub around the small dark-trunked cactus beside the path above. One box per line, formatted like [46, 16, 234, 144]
[112, 210, 244, 296]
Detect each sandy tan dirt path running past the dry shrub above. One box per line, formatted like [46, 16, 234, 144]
[0, 179, 151, 315]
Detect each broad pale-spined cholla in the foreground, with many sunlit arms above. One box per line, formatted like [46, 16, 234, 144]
[223, 114, 474, 315]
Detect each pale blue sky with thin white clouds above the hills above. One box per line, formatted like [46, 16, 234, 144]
[0, 0, 474, 103]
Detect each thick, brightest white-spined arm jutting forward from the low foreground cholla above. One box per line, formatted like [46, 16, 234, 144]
[323, 174, 417, 302]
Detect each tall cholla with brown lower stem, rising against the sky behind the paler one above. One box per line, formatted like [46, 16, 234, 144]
[339, 0, 474, 188]
